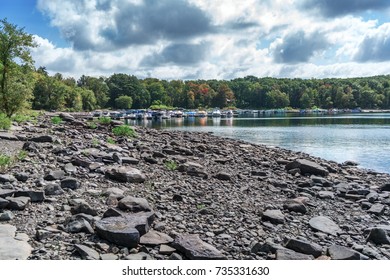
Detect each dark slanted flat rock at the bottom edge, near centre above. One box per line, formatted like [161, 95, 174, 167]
[172, 234, 226, 260]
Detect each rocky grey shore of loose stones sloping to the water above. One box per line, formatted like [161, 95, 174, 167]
[0, 114, 390, 260]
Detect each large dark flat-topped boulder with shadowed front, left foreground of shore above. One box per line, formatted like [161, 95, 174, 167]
[95, 212, 154, 248]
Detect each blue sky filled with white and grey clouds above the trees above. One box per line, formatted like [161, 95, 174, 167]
[0, 0, 390, 80]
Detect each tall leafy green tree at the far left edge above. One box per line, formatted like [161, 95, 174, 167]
[0, 19, 36, 117]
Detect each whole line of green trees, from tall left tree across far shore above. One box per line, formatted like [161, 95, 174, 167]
[0, 19, 390, 116]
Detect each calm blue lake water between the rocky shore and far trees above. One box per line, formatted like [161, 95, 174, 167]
[127, 113, 390, 173]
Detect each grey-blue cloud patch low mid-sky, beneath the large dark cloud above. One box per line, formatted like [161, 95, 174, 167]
[141, 43, 207, 67]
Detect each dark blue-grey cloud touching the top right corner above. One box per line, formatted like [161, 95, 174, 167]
[302, 0, 390, 18]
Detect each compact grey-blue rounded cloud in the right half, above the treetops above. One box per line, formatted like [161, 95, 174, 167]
[273, 31, 328, 64]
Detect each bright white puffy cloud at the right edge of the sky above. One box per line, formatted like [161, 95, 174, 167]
[354, 23, 390, 62]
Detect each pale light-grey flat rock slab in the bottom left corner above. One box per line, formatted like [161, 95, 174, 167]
[0, 224, 32, 260]
